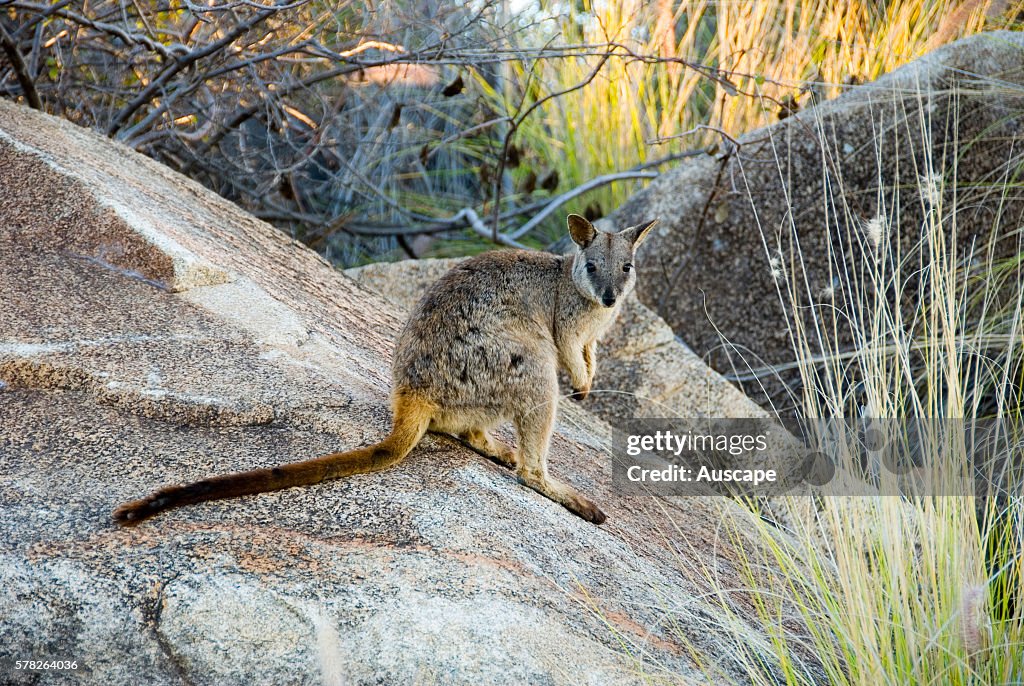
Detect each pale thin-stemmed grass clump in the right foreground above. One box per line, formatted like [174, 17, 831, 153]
[655, 64, 1024, 686]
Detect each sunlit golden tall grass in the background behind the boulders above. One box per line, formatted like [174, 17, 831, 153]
[490, 0, 1022, 245]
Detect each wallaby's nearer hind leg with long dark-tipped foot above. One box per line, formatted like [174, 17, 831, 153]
[515, 402, 606, 524]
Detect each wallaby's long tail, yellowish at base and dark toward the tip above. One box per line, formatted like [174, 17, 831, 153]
[114, 397, 431, 526]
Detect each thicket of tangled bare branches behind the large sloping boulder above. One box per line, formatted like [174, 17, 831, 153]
[0, 0, 745, 259]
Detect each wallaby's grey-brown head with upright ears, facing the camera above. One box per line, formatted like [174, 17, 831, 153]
[568, 214, 657, 307]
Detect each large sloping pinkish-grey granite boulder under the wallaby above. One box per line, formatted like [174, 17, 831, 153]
[0, 101, 813, 686]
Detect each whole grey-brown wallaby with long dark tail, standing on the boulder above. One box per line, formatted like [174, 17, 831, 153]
[114, 214, 655, 525]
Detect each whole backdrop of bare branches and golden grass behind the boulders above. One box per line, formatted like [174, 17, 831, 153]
[0, 0, 1019, 264]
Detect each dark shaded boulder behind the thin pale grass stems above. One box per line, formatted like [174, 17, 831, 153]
[606, 31, 1024, 413]
